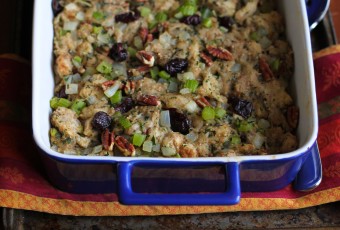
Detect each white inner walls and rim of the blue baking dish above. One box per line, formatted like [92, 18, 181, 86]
[32, 0, 318, 162]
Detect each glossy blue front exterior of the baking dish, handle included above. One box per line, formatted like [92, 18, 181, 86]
[42, 144, 321, 205]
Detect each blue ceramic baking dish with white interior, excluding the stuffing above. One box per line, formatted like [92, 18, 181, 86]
[32, 0, 321, 205]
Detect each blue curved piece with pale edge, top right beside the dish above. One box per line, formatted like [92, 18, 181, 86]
[306, 0, 330, 29]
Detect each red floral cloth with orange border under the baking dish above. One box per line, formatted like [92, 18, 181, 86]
[0, 46, 340, 216]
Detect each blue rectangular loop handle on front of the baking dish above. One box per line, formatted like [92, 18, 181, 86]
[118, 161, 241, 205]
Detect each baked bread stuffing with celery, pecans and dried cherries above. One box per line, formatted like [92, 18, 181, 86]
[50, 0, 299, 157]
